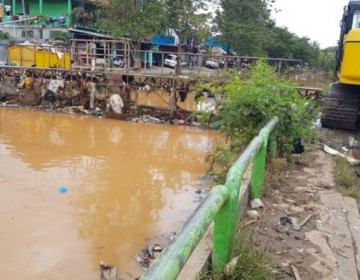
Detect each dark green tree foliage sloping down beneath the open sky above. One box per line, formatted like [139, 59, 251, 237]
[216, 0, 319, 66]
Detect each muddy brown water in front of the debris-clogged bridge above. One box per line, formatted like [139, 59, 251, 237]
[0, 108, 218, 280]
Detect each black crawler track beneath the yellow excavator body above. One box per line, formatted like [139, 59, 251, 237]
[321, 83, 360, 130]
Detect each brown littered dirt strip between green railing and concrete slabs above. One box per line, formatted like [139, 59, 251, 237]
[250, 145, 334, 280]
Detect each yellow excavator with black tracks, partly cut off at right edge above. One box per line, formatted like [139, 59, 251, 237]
[321, 1, 360, 130]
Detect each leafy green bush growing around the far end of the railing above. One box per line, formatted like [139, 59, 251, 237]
[208, 61, 317, 181]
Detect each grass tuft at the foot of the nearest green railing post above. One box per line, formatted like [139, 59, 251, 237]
[197, 230, 272, 280]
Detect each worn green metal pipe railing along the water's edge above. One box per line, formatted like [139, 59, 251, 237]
[140, 117, 278, 280]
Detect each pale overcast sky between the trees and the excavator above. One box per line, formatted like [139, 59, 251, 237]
[273, 0, 349, 48]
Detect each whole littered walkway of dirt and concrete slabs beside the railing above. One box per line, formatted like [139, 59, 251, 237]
[252, 138, 360, 280]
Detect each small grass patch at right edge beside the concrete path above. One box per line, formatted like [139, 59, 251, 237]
[335, 157, 360, 202]
